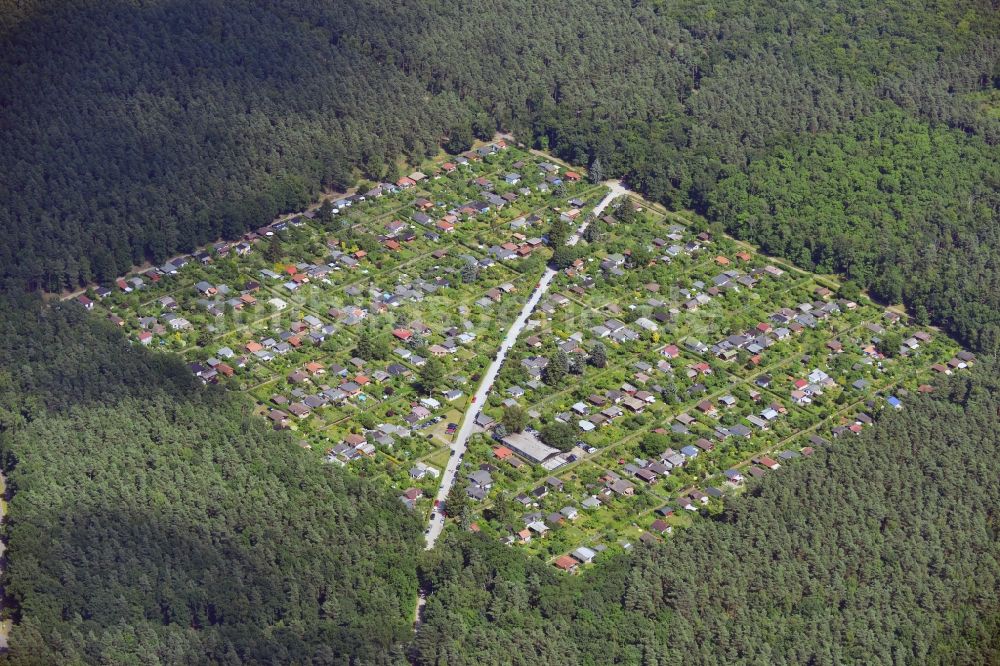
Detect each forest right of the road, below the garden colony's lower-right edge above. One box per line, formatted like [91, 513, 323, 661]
[413, 366, 1000, 665]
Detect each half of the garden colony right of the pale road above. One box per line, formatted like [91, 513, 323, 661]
[458, 196, 974, 568]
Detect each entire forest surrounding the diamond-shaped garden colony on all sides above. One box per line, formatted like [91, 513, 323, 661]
[0, 0, 1000, 664]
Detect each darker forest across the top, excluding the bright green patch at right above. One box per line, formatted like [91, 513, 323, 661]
[0, 0, 1000, 331]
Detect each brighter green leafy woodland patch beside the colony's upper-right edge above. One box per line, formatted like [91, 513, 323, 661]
[710, 111, 1000, 352]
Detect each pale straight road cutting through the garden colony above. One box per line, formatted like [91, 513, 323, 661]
[426, 180, 628, 550]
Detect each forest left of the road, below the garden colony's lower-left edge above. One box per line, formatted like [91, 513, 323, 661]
[0, 300, 420, 664]
